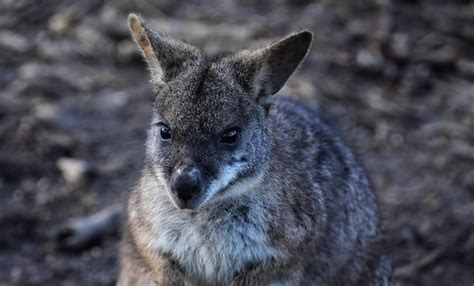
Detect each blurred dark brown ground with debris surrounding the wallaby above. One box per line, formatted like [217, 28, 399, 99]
[0, 0, 474, 286]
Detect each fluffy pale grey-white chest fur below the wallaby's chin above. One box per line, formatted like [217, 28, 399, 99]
[130, 188, 281, 281]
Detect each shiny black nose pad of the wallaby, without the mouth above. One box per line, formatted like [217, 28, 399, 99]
[170, 169, 201, 203]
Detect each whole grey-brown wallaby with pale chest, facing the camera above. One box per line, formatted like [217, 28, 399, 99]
[118, 14, 391, 285]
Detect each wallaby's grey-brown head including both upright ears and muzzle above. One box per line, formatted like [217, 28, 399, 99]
[129, 14, 312, 209]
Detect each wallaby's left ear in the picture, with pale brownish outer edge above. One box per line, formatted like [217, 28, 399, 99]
[128, 14, 202, 85]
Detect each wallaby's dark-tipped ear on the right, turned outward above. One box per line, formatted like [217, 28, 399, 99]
[235, 31, 313, 101]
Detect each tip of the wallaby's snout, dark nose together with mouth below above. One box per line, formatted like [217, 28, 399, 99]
[170, 167, 202, 209]
